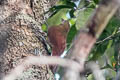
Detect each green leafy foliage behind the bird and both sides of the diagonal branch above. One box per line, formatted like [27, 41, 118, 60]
[43, 0, 120, 80]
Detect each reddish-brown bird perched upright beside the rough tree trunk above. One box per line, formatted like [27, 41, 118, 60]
[48, 21, 70, 56]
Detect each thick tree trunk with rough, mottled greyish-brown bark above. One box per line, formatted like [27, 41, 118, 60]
[0, 0, 57, 80]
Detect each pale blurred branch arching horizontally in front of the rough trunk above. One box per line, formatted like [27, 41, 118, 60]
[3, 56, 82, 80]
